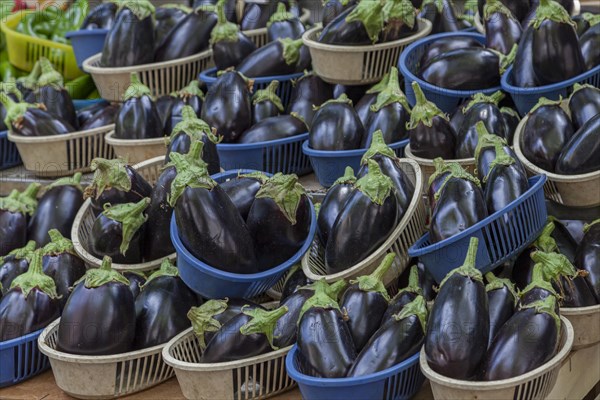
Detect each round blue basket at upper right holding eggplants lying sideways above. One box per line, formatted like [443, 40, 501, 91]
[398, 31, 502, 113]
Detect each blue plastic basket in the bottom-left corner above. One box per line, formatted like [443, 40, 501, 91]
[0, 329, 50, 387]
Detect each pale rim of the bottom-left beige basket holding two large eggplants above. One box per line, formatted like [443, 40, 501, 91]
[38, 318, 168, 364]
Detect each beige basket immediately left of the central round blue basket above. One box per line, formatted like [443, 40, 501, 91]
[71, 156, 177, 271]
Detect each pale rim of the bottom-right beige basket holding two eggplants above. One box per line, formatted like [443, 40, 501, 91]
[419, 316, 575, 392]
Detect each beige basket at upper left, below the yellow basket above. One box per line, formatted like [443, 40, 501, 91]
[8, 125, 114, 177]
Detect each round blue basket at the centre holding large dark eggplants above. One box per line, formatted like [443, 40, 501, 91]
[171, 170, 317, 299]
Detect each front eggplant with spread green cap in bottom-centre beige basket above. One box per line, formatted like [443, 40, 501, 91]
[200, 307, 288, 364]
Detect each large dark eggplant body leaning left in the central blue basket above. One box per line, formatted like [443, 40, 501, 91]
[175, 186, 259, 274]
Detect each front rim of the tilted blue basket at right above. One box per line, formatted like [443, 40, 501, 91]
[408, 175, 546, 257]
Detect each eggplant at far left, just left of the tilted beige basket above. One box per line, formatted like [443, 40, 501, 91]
[27, 172, 83, 247]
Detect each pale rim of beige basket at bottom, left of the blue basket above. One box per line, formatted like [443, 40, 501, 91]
[162, 327, 293, 372]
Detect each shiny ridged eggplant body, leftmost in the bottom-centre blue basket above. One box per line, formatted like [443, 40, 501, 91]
[297, 307, 357, 378]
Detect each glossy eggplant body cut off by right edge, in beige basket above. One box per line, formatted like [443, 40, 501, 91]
[556, 114, 600, 175]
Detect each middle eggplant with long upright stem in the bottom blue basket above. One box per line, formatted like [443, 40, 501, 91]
[340, 253, 396, 353]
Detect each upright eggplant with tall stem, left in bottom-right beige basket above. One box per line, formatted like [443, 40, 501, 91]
[425, 237, 490, 380]
